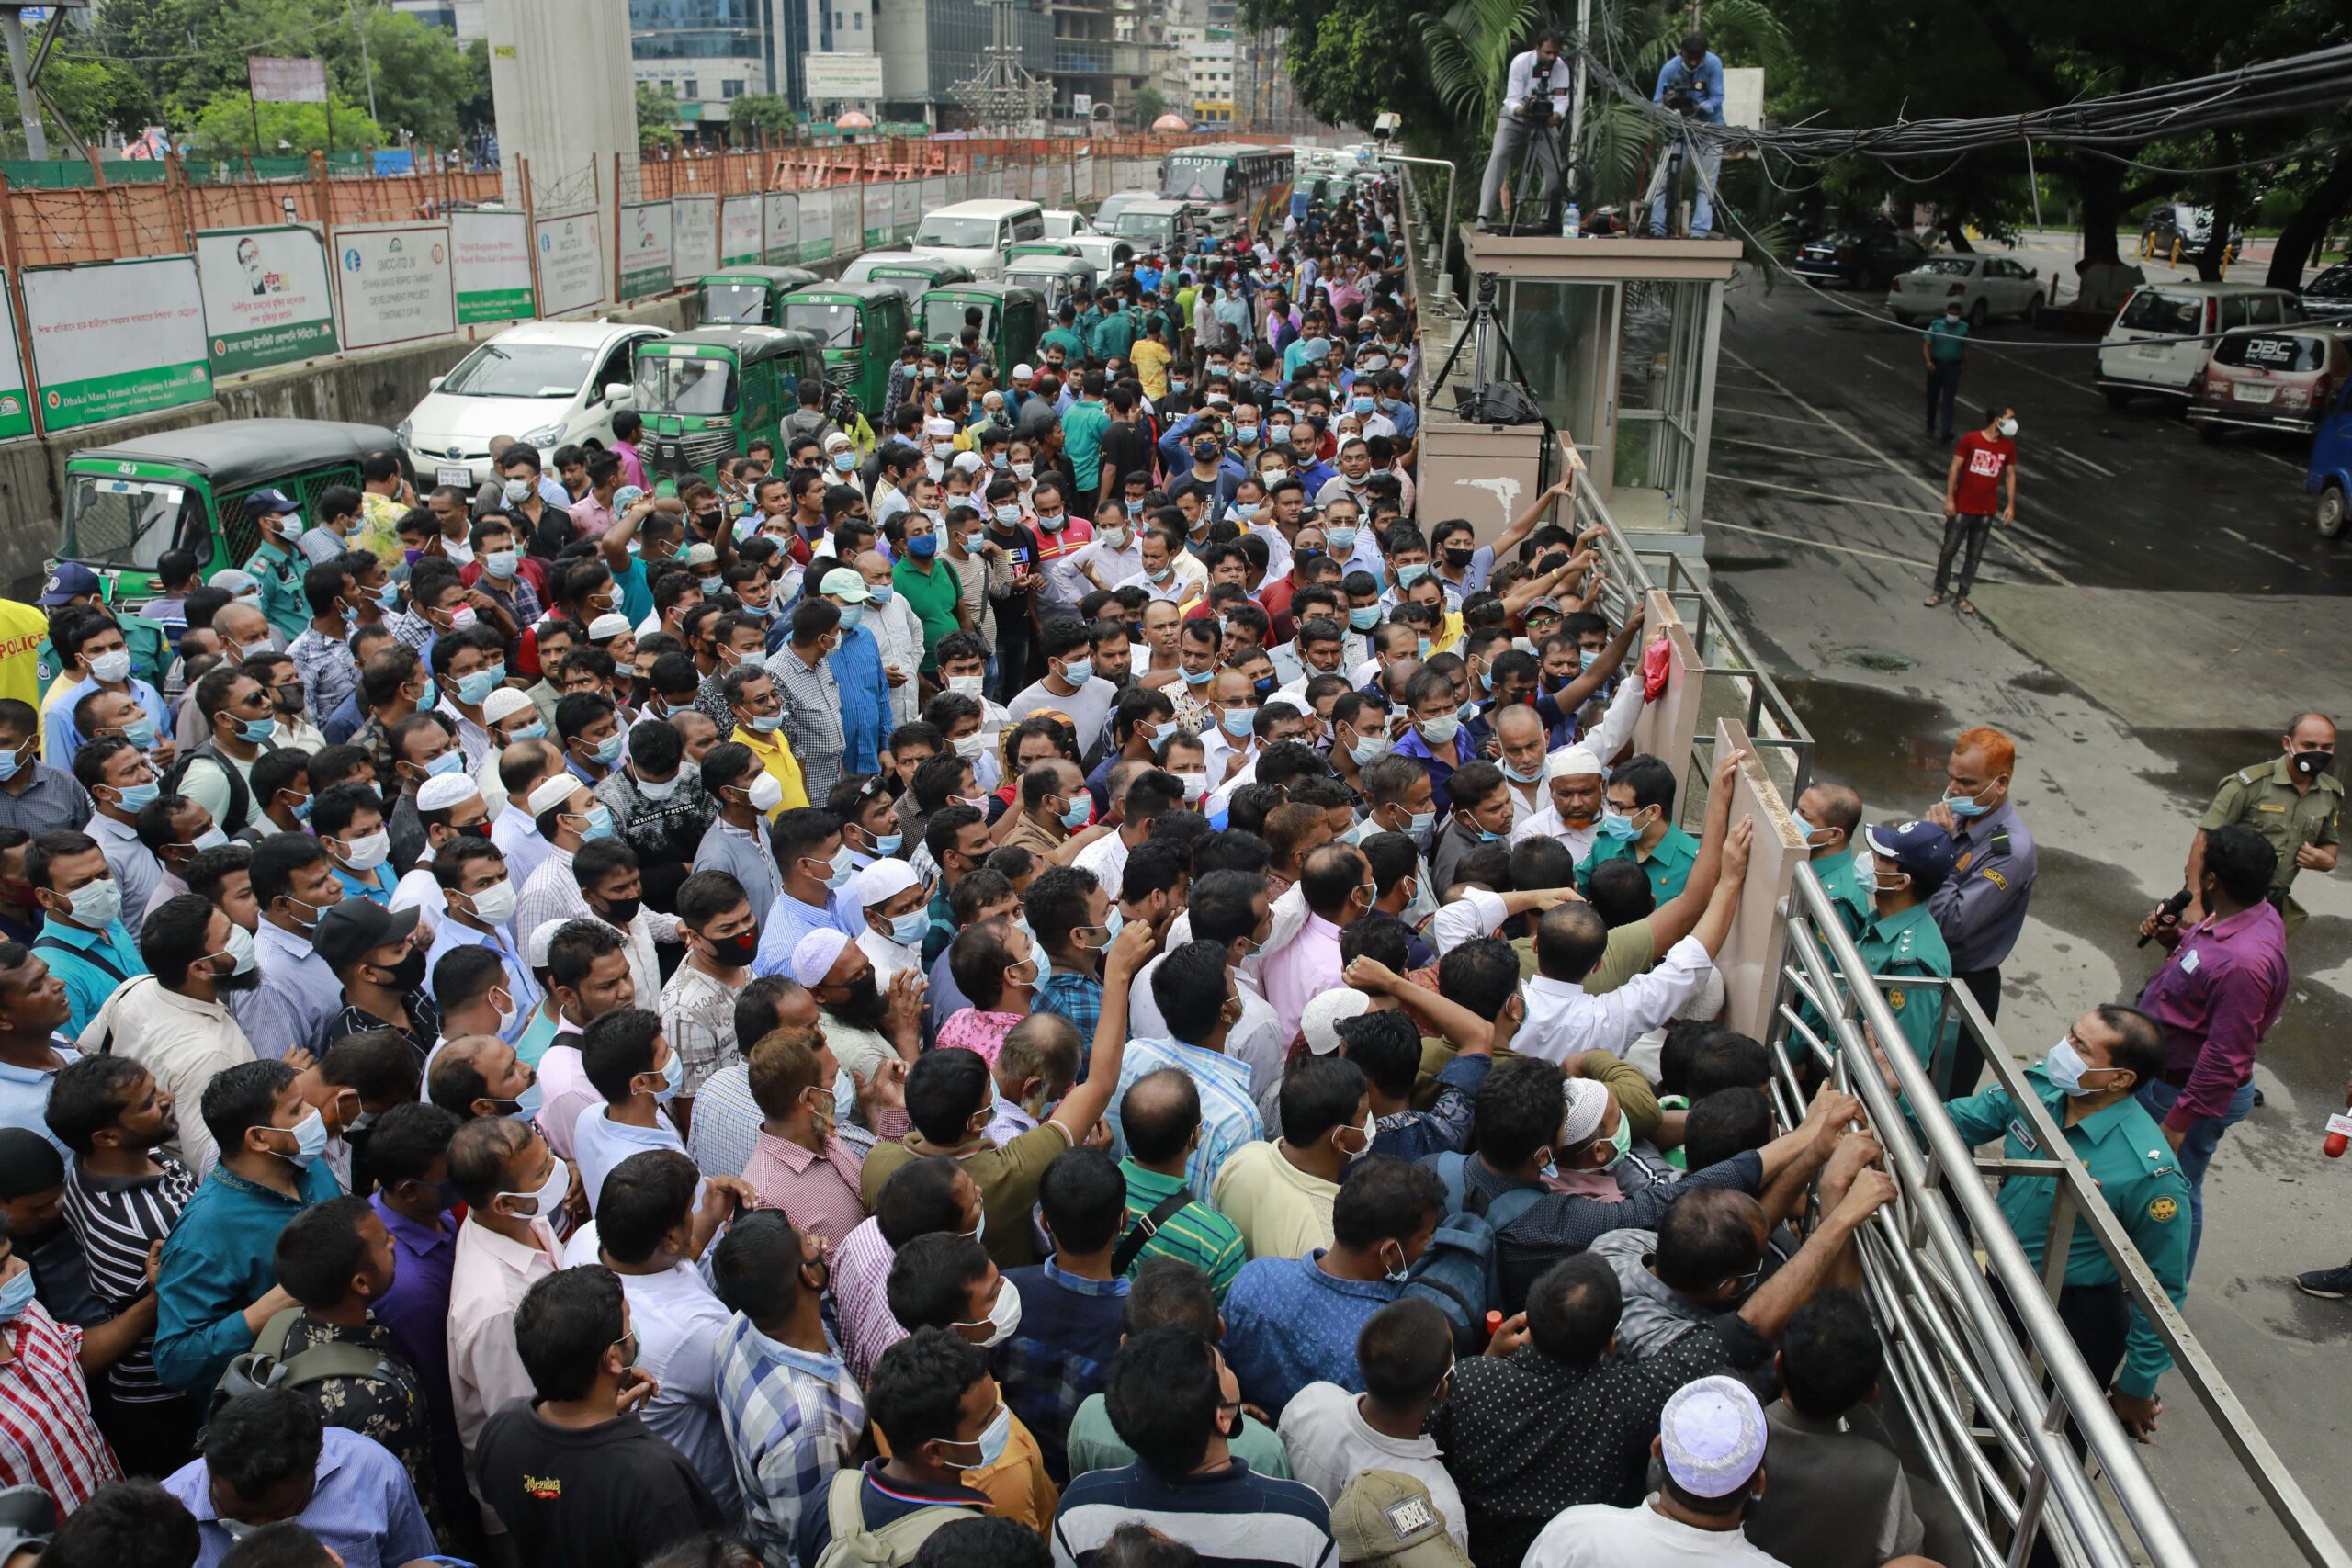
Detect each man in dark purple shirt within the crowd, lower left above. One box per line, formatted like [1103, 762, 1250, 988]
[367, 1100, 478, 1540]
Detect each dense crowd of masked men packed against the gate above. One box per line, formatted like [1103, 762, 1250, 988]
[0, 165, 2267, 1568]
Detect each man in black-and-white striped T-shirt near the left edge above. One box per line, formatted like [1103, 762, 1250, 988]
[50, 1055, 202, 1476]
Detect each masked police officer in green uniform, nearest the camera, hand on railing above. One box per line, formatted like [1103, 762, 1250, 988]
[1886, 1006, 2189, 1438]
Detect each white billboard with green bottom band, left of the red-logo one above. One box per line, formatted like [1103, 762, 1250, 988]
[24, 256, 211, 433]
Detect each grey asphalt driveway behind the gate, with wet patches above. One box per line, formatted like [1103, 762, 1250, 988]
[1705, 265, 2352, 1568]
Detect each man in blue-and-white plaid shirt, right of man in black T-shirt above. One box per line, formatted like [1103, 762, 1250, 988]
[710, 1208, 865, 1563]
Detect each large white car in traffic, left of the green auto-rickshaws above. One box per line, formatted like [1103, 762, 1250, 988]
[395, 322, 671, 489]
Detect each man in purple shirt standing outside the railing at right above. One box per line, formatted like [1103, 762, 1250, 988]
[2141, 828, 2289, 1269]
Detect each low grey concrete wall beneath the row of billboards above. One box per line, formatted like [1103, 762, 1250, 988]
[0, 294, 696, 600]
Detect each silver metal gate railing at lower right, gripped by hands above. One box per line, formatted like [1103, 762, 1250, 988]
[1771, 865, 2352, 1568]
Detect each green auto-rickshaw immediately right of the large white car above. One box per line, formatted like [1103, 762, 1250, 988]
[630, 327, 826, 482]
